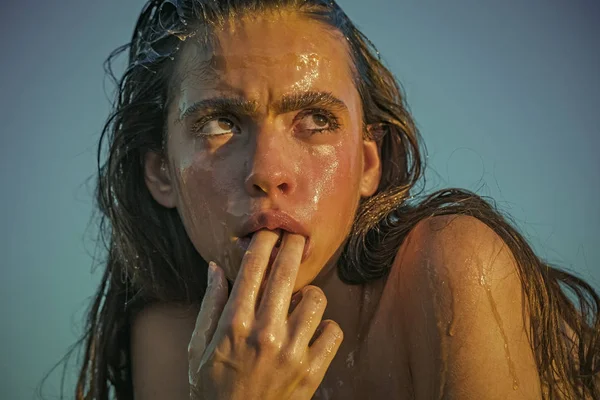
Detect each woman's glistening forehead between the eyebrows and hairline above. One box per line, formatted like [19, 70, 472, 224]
[171, 13, 354, 102]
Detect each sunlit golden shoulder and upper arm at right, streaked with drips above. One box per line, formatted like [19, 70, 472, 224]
[390, 215, 541, 400]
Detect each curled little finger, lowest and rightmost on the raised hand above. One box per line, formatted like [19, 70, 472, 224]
[308, 319, 344, 382]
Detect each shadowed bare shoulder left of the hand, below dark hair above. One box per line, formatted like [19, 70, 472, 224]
[131, 304, 200, 400]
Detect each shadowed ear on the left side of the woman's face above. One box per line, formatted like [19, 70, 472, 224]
[144, 151, 177, 208]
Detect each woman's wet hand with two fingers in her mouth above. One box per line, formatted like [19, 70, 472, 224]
[188, 230, 343, 400]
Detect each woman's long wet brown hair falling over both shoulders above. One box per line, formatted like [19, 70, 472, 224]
[39, 0, 600, 400]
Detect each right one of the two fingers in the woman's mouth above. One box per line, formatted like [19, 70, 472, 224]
[256, 233, 306, 322]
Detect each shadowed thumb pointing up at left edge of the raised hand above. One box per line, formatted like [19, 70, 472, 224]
[188, 261, 227, 382]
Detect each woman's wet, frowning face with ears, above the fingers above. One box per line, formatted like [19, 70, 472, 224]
[146, 10, 380, 290]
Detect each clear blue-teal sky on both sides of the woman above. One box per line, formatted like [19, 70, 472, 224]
[0, 0, 600, 399]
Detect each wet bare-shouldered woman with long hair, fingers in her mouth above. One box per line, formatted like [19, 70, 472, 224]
[63, 0, 600, 399]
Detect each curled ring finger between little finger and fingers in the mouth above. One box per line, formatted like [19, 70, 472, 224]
[288, 286, 327, 351]
